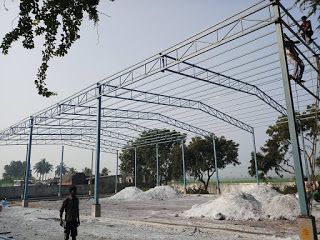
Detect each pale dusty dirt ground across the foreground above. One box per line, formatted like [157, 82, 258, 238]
[0, 195, 320, 240]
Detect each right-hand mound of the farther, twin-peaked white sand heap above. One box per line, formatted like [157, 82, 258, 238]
[137, 186, 180, 200]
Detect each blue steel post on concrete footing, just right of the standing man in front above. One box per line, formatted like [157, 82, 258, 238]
[92, 84, 102, 217]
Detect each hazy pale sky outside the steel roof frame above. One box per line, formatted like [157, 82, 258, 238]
[0, 0, 316, 180]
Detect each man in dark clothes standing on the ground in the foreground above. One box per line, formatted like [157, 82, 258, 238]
[60, 187, 80, 240]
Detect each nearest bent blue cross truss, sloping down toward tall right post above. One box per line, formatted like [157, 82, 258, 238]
[162, 55, 287, 116]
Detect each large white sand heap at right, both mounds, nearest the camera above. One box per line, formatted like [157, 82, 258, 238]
[182, 186, 299, 220]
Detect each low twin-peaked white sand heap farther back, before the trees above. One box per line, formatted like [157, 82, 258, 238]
[110, 186, 180, 201]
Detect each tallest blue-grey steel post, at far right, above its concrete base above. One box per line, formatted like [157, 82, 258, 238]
[273, 0, 309, 216]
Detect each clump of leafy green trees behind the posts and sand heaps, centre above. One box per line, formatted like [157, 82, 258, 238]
[120, 129, 240, 191]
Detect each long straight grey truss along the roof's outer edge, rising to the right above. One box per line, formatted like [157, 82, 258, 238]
[2, 1, 274, 137]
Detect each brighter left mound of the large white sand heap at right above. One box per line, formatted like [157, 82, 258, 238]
[183, 193, 261, 220]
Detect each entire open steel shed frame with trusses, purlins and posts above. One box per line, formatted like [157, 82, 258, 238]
[0, 0, 320, 226]
